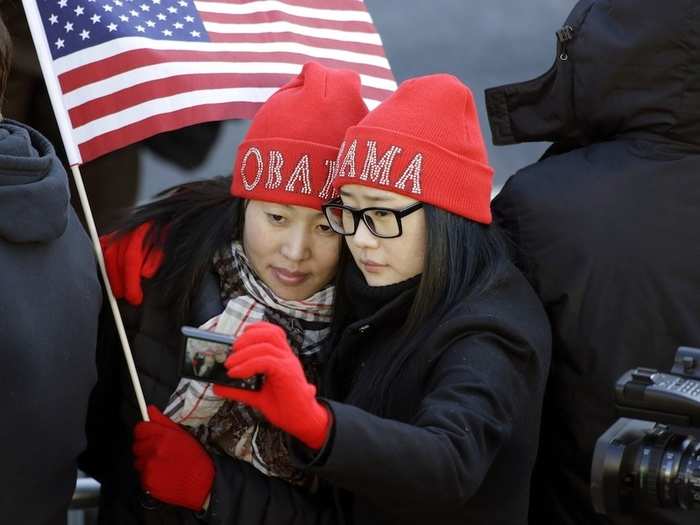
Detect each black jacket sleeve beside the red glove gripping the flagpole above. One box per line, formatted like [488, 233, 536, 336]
[207, 456, 346, 525]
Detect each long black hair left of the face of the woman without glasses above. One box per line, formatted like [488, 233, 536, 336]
[106, 176, 245, 323]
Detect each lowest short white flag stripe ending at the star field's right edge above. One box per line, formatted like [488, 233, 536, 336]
[204, 21, 382, 46]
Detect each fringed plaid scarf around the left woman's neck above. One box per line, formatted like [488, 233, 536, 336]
[165, 242, 335, 485]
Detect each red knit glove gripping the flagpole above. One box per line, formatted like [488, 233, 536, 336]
[133, 405, 214, 511]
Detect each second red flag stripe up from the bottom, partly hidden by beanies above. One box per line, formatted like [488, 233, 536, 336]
[68, 73, 391, 128]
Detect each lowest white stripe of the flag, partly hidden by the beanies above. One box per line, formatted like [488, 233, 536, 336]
[73, 88, 379, 144]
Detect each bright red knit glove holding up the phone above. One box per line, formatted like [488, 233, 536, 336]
[214, 322, 331, 450]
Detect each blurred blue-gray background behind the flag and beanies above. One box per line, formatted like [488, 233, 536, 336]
[139, 0, 576, 201]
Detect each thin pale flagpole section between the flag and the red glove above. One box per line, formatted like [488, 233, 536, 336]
[71, 166, 149, 421]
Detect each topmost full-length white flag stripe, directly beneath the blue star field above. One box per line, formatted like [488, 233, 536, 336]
[54, 37, 391, 75]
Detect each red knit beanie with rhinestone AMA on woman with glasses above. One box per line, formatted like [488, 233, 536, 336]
[333, 74, 493, 224]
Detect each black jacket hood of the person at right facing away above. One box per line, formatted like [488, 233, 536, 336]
[486, 0, 700, 146]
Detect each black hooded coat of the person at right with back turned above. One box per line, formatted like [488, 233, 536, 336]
[486, 0, 700, 525]
